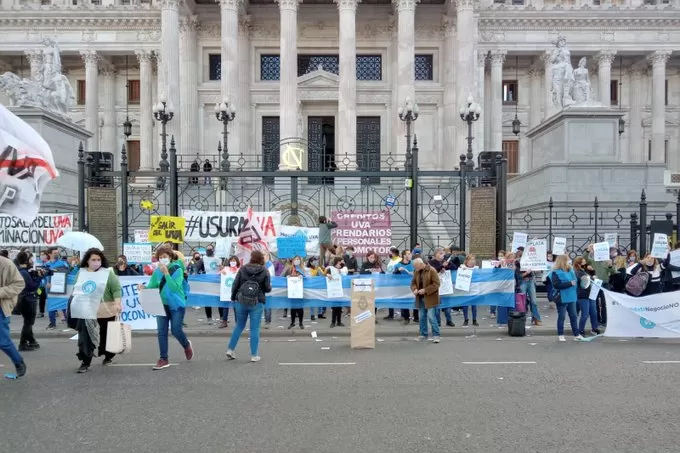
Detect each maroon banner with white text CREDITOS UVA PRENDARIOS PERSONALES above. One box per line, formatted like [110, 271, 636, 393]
[331, 211, 392, 256]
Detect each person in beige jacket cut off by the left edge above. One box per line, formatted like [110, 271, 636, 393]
[0, 252, 26, 377]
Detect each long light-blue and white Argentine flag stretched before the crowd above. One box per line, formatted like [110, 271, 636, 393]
[47, 269, 515, 310]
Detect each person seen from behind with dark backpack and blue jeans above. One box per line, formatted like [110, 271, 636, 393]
[227, 250, 272, 362]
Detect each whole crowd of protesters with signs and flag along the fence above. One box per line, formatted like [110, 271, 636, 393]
[0, 208, 680, 376]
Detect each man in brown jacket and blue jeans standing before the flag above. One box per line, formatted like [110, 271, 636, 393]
[411, 258, 440, 343]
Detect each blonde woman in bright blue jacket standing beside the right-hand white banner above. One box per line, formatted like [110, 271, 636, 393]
[550, 255, 583, 341]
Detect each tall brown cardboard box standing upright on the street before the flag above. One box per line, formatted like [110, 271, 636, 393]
[350, 279, 375, 349]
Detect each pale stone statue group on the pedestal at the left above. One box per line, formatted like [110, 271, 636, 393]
[0, 38, 75, 117]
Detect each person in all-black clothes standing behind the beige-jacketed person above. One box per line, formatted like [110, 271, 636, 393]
[16, 252, 45, 351]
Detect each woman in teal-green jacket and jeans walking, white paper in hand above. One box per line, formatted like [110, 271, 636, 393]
[139, 247, 194, 370]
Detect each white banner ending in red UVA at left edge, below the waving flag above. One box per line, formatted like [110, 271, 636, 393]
[0, 214, 73, 247]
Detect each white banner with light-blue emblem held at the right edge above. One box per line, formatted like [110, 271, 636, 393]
[604, 291, 680, 338]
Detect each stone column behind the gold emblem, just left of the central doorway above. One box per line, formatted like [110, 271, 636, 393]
[278, 0, 300, 160]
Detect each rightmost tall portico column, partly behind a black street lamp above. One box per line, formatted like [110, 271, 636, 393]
[454, 0, 478, 156]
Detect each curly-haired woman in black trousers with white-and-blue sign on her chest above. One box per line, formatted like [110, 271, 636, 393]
[69, 249, 123, 374]
